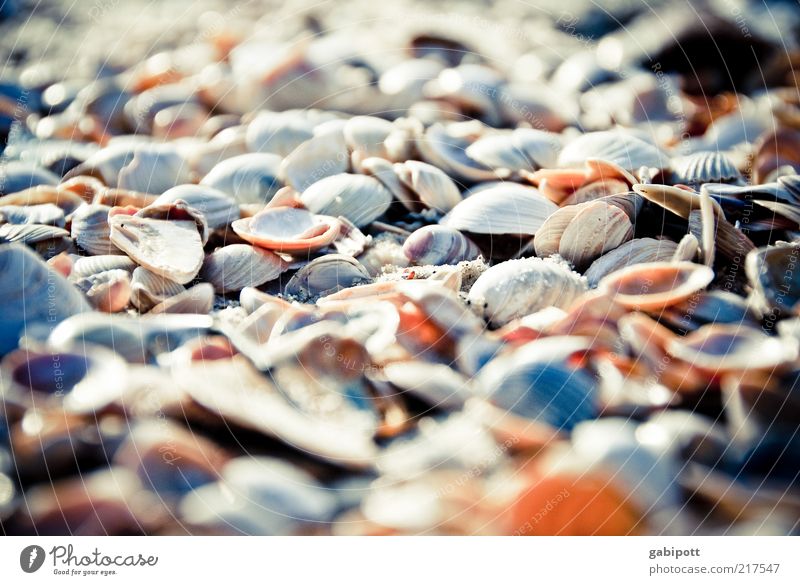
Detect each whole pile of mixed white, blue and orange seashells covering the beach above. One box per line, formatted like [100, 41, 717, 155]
[0, 0, 800, 535]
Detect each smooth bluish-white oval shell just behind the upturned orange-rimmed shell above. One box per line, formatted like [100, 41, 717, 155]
[300, 173, 392, 227]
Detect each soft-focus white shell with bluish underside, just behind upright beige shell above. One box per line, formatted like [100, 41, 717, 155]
[245, 112, 314, 157]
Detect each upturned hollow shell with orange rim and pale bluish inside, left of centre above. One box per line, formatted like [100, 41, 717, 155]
[232, 207, 341, 254]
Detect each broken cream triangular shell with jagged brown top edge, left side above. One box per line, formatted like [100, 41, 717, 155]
[109, 205, 205, 284]
